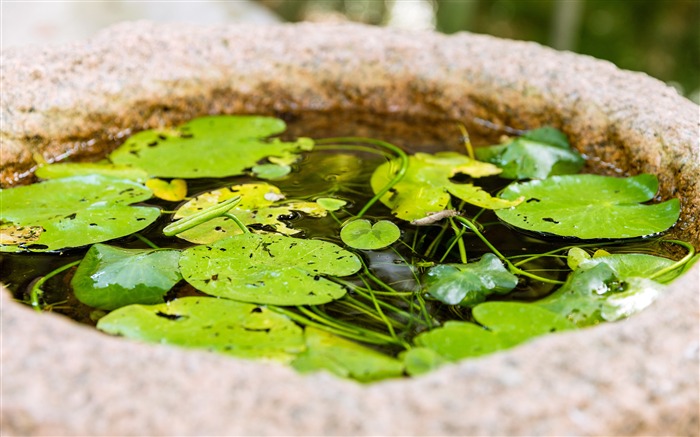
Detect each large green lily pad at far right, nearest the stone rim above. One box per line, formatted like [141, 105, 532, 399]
[496, 174, 680, 240]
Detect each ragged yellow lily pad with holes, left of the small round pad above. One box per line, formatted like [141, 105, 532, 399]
[174, 182, 327, 244]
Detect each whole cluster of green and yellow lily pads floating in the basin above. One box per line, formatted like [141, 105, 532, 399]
[0, 116, 694, 382]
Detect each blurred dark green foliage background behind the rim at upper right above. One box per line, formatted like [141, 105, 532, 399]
[256, 0, 700, 103]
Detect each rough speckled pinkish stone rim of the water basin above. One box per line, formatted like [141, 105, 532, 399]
[0, 22, 700, 436]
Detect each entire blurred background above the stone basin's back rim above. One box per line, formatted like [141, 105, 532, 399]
[1, 0, 700, 102]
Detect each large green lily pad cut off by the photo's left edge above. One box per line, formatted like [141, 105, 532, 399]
[0, 175, 160, 252]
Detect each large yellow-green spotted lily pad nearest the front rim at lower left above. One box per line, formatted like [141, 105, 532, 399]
[97, 297, 305, 362]
